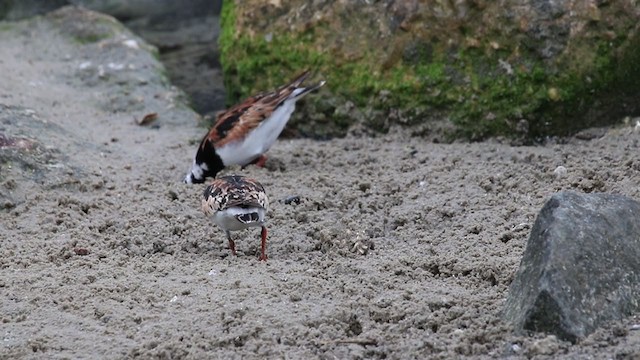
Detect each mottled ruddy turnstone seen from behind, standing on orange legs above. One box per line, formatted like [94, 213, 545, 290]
[202, 175, 269, 261]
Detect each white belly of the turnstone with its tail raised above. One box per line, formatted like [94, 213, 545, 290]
[216, 99, 297, 166]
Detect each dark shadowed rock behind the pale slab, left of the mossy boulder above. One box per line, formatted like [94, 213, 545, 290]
[0, 0, 224, 115]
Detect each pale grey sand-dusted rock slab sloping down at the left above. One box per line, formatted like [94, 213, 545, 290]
[0, 6, 197, 208]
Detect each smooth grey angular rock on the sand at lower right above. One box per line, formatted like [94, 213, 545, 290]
[503, 191, 640, 342]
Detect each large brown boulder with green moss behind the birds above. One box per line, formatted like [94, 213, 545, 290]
[220, 0, 640, 138]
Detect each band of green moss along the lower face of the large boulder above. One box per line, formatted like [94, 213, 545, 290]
[219, 2, 640, 139]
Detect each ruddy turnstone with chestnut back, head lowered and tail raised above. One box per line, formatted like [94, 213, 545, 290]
[184, 71, 325, 184]
